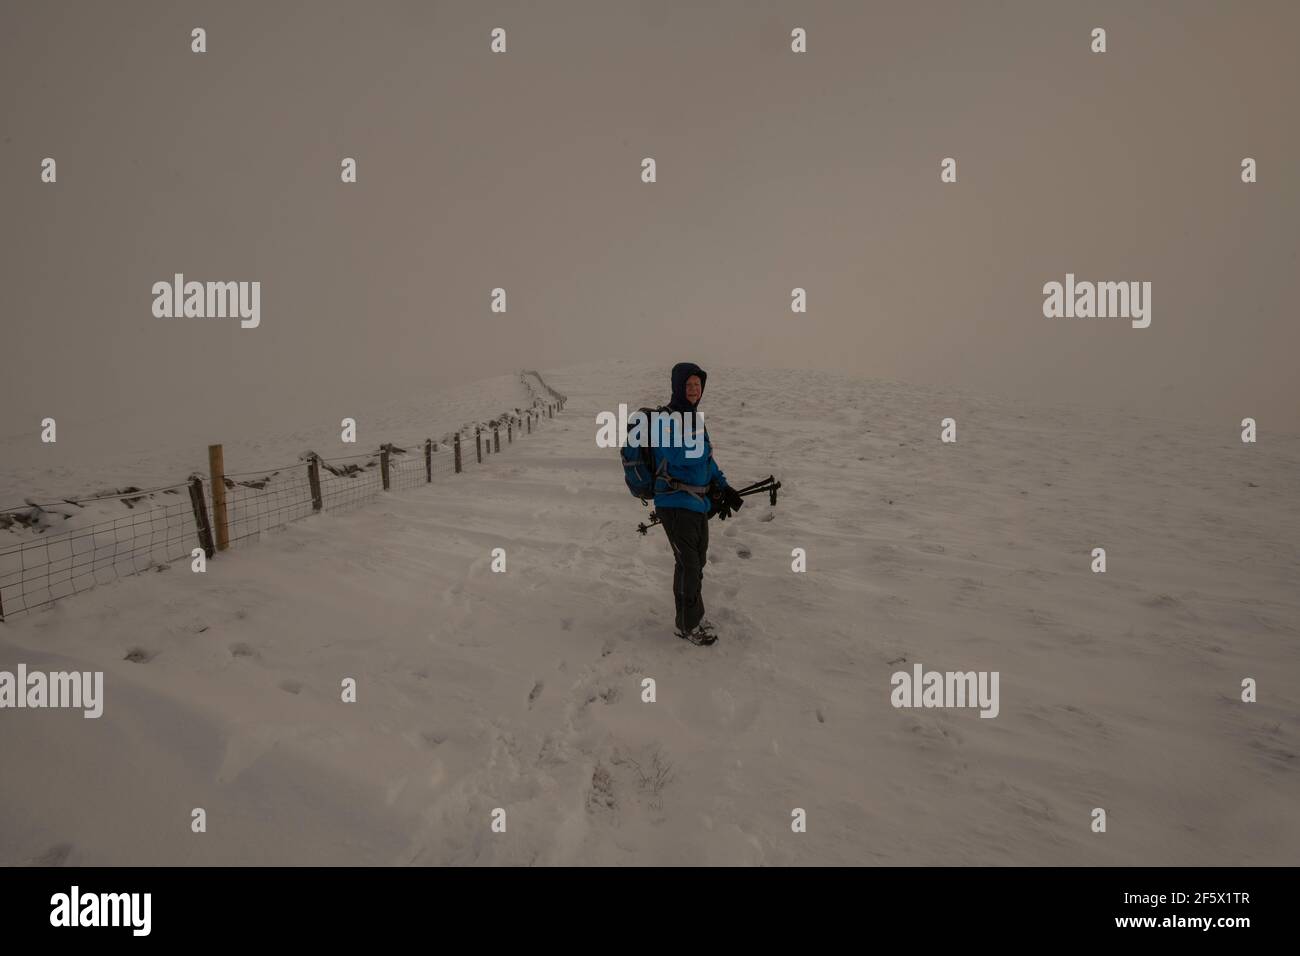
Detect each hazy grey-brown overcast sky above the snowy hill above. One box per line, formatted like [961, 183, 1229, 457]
[0, 0, 1300, 436]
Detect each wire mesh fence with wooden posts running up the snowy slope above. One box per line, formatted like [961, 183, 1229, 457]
[0, 369, 567, 622]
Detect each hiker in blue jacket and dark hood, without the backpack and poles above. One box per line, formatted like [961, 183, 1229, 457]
[654, 362, 744, 645]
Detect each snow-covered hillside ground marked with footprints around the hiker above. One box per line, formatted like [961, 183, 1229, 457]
[0, 362, 1300, 865]
